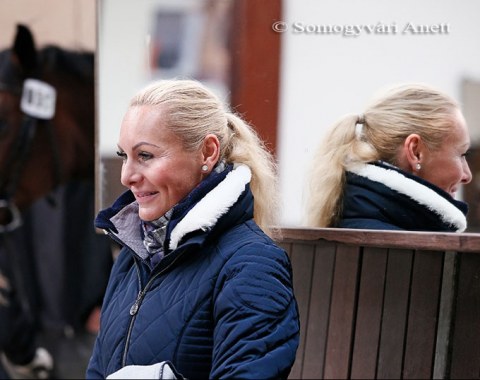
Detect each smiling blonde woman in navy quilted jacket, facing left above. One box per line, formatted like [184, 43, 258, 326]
[86, 80, 299, 379]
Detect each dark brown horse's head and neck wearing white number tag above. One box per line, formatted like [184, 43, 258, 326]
[0, 25, 95, 229]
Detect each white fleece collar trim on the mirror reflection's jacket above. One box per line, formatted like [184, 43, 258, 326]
[349, 164, 467, 232]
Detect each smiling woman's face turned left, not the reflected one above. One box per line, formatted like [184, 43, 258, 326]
[118, 106, 203, 221]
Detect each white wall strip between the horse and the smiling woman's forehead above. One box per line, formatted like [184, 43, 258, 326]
[97, 0, 201, 155]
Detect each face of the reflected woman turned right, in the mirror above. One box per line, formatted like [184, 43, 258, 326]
[419, 110, 472, 197]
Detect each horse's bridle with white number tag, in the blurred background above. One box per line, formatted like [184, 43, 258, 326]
[0, 78, 62, 233]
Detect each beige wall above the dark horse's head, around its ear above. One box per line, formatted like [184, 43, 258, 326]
[0, 0, 97, 50]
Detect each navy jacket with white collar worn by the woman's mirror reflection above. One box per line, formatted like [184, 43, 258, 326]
[337, 161, 468, 232]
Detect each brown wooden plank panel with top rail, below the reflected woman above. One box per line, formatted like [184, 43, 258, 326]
[279, 228, 480, 379]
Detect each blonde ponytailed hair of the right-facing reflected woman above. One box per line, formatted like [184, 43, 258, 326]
[306, 83, 459, 227]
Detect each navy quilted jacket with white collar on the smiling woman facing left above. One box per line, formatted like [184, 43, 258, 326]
[86, 166, 299, 379]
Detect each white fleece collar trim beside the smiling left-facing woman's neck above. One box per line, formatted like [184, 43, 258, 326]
[169, 165, 252, 250]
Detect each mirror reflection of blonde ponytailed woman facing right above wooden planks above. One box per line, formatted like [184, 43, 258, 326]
[307, 83, 472, 232]
